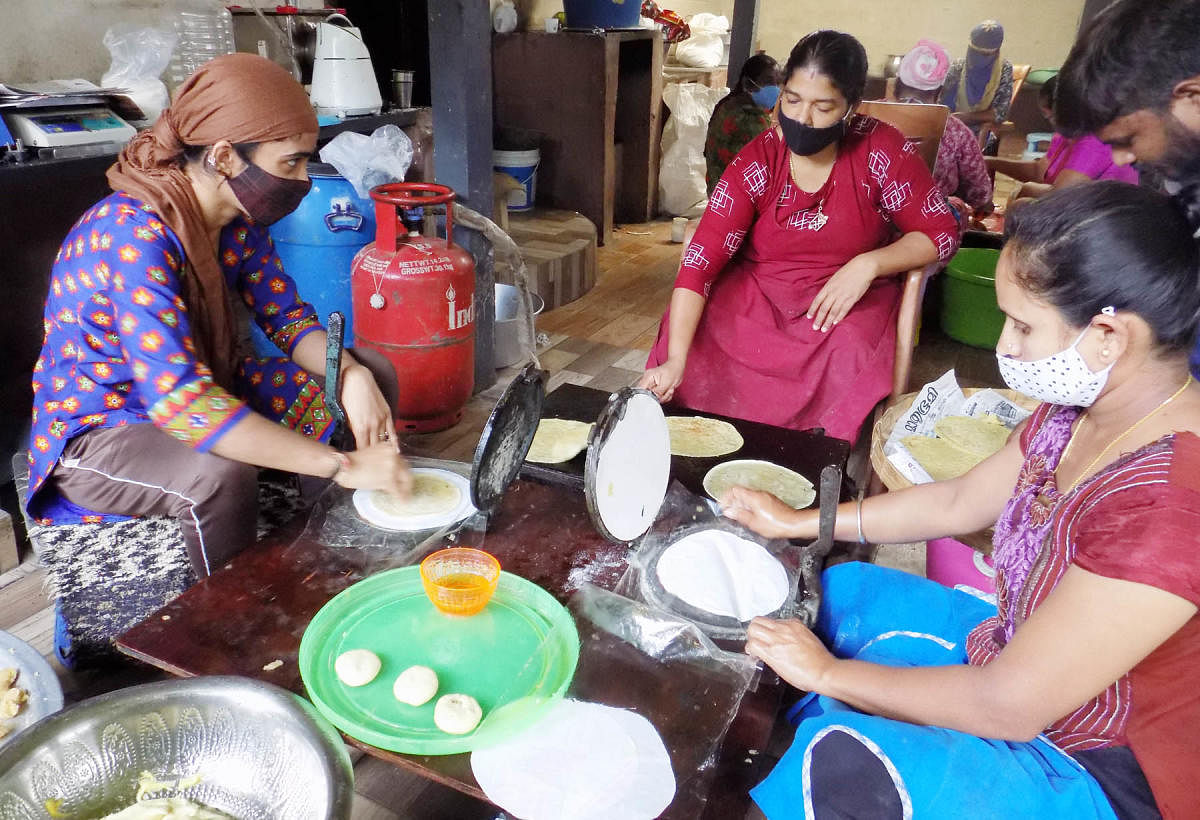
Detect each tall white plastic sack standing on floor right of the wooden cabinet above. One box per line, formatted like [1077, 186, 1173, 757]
[659, 83, 728, 216]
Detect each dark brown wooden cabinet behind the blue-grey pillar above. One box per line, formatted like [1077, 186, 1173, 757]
[492, 29, 662, 244]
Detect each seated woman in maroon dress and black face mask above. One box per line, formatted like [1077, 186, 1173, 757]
[638, 31, 958, 439]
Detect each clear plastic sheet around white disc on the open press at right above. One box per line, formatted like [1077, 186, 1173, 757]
[617, 481, 815, 641]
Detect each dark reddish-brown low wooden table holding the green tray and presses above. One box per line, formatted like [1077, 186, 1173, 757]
[116, 390, 848, 820]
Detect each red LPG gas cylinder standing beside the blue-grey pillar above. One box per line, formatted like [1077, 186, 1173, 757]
[350, 182, 475, 432]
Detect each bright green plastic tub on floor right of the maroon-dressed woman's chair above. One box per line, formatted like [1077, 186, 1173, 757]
[940, 247, 1004, 349]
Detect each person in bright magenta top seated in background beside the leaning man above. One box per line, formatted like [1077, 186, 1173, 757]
[986, 77, 1138, 199]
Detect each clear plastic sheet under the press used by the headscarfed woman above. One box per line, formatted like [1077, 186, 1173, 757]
[300, 457, 487, 571]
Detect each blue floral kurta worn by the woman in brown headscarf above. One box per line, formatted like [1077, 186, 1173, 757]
[26, 193, 332, 523]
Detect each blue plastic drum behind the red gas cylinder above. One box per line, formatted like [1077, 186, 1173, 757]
[250, 162, 374, 357]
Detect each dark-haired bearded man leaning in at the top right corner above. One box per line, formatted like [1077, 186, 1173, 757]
[1055, 0, 1200, 378]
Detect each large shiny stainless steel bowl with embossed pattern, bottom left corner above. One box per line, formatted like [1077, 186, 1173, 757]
[0, 677, 354, 820]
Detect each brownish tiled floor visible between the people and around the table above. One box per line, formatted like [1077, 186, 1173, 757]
[0, 158, 1004, 820]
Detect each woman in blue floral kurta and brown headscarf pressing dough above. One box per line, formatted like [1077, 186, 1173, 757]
[28, 54, 409, 576]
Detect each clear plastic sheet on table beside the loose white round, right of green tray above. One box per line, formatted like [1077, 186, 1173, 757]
[568, 583, 758, 818]
